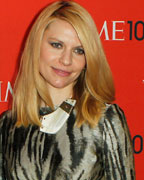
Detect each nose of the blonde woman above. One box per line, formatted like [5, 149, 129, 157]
[59, 50, 72, 66]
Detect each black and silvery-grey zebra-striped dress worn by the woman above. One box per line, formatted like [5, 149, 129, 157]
[0, 105, 135, 180]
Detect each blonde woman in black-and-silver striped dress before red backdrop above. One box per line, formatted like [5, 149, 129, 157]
[0, 1, 135, 180]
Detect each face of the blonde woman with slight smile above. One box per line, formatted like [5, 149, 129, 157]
[39, 19, 86, 88]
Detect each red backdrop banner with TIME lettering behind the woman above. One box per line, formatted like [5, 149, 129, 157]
[0, 0, 144, 180]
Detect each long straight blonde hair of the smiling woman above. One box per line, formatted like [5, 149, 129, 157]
[12, 1, 115, 127]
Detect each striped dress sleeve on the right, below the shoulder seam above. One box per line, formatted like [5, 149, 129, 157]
[103, 104, 135, 180]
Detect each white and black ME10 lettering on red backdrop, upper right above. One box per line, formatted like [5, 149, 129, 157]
[99, 21, 144, 41]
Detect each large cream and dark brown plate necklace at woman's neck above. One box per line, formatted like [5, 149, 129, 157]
[40, 99, 76, 134]
